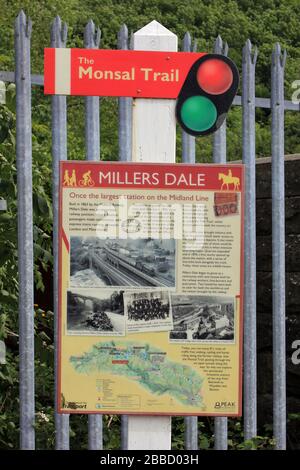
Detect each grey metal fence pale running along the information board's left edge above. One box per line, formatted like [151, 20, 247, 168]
[51, 16, 70, 450]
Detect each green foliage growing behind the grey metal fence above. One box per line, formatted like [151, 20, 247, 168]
[0, 0, 300, 449]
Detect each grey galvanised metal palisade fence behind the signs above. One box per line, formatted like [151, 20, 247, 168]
[0, 11, 290, 450]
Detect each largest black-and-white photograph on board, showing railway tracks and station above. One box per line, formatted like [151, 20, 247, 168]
[70, 236, 176, 288]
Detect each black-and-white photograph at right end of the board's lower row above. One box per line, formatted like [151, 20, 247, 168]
[170, 294, 235, 343]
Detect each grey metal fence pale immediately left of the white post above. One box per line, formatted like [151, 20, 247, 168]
[118, 24, 132, 450]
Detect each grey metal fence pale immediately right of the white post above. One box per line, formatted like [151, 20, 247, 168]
[181, 33, 198, 450]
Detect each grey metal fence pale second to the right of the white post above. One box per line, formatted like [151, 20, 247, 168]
[213, 36, 228, 450]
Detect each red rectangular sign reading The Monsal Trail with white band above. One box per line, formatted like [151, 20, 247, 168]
[44, 48, 204, 99]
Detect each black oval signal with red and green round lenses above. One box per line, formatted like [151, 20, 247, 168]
[176, 54, 239, 136]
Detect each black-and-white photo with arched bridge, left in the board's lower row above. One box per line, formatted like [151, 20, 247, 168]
[67, 289, 125, 336]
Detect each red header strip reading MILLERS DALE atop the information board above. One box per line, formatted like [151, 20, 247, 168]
[61, 161, 243, 195]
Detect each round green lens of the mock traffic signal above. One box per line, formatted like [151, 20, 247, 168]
[181, 96, 218, 132]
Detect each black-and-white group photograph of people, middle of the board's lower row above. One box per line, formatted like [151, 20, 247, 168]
[124, 290, 173, 333]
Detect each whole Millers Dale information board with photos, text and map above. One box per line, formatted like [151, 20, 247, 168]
[57, 161, 244, 416]
